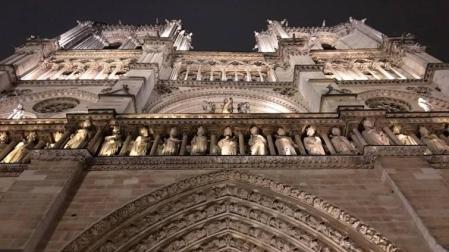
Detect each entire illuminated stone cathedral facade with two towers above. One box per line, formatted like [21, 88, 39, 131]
[0, 18, 449, 252]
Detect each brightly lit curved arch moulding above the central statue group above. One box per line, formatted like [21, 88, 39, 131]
[146, 88, 308, 113]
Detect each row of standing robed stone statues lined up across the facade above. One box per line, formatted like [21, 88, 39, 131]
[0, 118, 449, 163]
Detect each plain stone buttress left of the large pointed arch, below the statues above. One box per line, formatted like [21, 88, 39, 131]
[0, 150, 91, 252]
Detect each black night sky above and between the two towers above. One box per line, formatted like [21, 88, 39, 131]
[0, 0, 449, 61]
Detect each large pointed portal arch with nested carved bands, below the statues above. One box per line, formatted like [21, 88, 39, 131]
[63, 170, 399, 252]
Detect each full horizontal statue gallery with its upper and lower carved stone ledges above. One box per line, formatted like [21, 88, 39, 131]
[0, 110, 449, 170]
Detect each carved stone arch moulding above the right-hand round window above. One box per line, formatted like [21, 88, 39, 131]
[357, 89, 449, 110]
